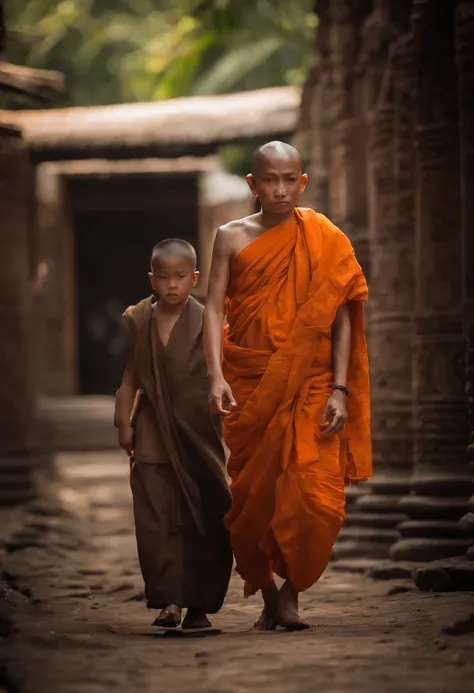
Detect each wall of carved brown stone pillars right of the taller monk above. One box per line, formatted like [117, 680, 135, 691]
[295, 0, 474, 560]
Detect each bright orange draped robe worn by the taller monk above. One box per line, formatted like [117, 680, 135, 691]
[223, 208, 372, 596]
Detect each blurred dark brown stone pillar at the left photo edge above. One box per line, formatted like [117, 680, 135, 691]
[0, 126, 35, 505]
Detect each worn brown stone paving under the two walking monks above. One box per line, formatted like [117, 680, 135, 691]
[0, 452, 474, 693]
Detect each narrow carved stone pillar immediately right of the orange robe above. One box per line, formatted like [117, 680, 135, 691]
[344, 84, 413, 557]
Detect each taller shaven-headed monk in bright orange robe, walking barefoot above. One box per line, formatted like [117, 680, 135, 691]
[203, 142, 371, 630]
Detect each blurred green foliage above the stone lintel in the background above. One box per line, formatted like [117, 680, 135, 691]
[6, 0, 317, 105]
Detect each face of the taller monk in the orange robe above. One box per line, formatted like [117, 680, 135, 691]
[247, 154, 308, 214]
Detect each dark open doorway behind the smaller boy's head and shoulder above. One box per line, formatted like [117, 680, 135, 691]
[70, 175, 198, 395]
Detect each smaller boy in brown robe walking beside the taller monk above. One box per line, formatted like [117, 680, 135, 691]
[115, 239, 233, 629]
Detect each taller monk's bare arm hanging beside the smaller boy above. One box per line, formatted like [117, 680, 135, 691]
[203, 229, 235, 415]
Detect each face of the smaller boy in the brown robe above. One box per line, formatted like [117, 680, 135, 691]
[149, 254, 199, 307]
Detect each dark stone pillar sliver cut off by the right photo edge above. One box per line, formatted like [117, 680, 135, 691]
[455, 2, 474, 559]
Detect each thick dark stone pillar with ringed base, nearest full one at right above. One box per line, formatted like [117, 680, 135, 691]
[391, 0, 473, 561]
